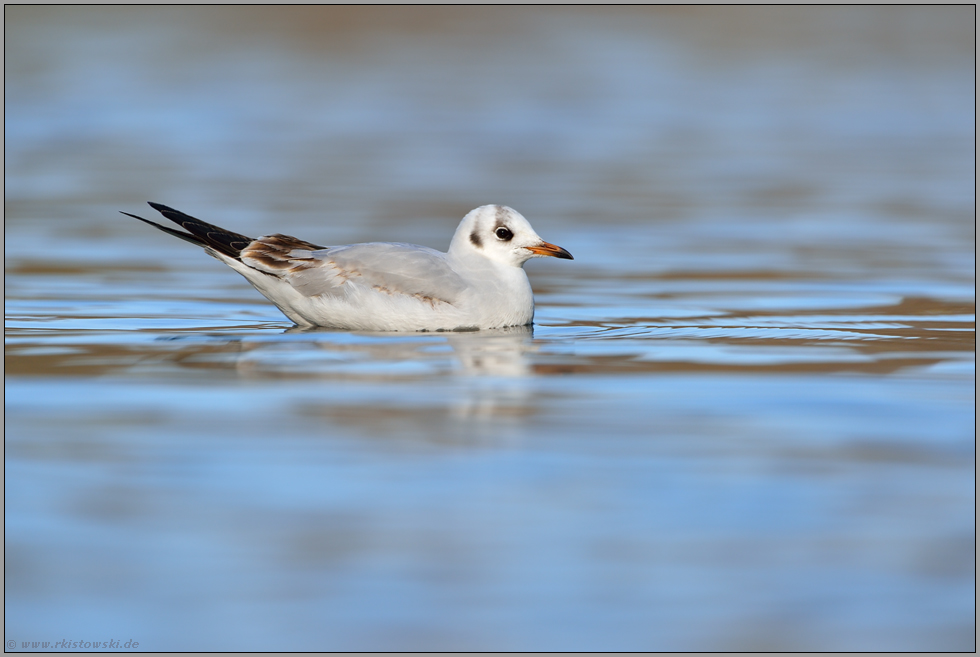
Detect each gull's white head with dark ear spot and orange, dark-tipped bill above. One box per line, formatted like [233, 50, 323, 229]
[449, 205, 572, 267]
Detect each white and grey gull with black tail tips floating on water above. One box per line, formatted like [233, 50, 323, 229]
[122, 202, 572, 331]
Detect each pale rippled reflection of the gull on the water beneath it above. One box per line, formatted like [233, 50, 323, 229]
[217, 326, 538, 430]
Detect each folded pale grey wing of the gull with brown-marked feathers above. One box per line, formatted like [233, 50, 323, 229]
[240, 235, 466, 304]
